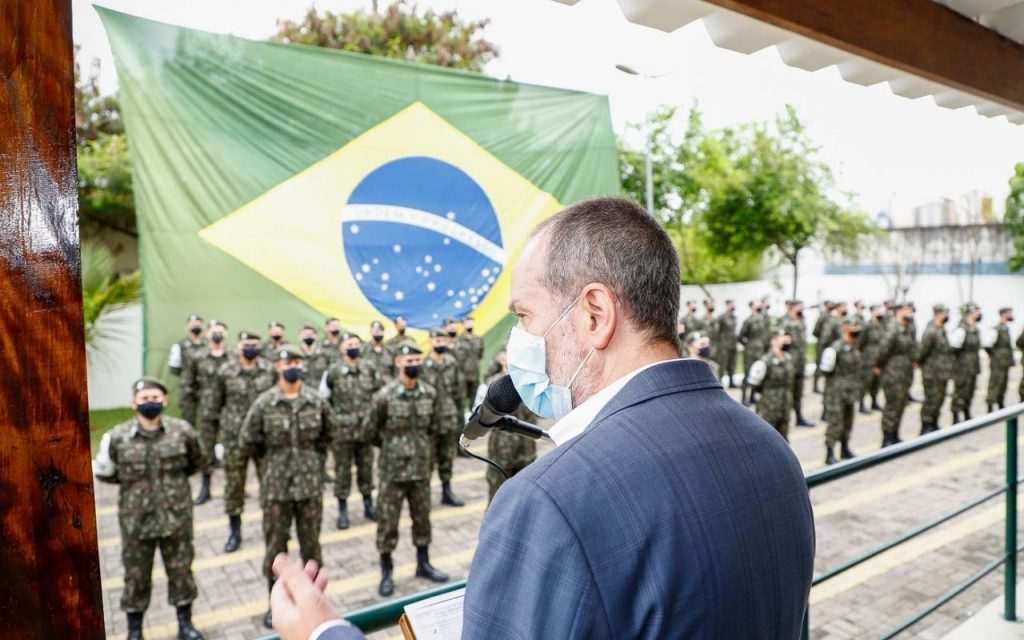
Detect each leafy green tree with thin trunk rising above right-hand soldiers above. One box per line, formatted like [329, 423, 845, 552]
[698, 105, 876, 296]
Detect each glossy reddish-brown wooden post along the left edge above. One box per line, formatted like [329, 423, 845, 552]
[0, 0, 104, 639]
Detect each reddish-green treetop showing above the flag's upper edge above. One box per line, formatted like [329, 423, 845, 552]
[271, 0, 499, 72]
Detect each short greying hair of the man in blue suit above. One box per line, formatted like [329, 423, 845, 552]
[534, 196, 679, 344]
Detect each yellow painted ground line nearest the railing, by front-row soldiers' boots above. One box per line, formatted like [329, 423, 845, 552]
[108, 549, 475, 640]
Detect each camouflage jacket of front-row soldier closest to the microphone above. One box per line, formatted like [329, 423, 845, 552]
[362, 380, 441, 482]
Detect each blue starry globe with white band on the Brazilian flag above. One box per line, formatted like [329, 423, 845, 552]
[341, 157, 505, 329]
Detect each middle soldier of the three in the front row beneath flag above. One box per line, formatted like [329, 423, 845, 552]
[241, 345, 331, 629]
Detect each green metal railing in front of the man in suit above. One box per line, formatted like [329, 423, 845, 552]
[259, 402, 1024, 640]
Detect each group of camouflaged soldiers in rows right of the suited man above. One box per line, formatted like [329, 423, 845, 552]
[679, 299, 1024, 464]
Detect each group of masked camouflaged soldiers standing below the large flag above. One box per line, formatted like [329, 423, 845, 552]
[93, 315, 495, 640]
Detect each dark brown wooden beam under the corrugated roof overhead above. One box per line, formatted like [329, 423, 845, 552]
[707, 0, 1024, 111]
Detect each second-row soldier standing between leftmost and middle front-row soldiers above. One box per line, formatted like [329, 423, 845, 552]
[212, 331, 275, 553]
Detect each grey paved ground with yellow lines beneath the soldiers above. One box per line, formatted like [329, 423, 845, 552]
[96, 368, 1024, 640]
